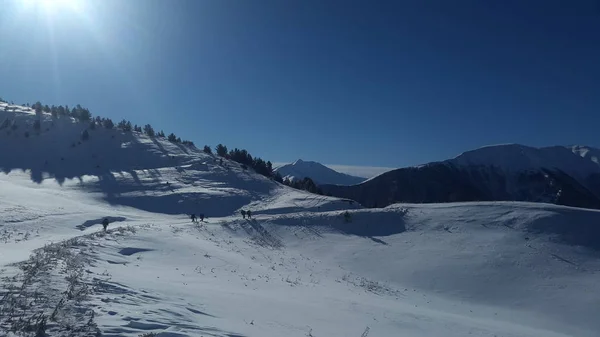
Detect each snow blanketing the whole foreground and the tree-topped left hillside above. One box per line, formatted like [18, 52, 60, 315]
[0, 104, 600, 337]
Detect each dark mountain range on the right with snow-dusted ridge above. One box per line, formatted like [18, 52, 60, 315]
[321, 144, 600, 209]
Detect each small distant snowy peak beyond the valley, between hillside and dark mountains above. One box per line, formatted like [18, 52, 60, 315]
[275, 159, 366, 185]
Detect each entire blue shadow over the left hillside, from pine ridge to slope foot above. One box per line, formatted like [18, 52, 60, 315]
[0, 112, 276, 217]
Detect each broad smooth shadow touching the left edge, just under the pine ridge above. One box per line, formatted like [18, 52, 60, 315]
[0, 112, 178, 189]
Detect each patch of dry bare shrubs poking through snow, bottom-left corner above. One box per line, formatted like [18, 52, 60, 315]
[0, 238, 99, 336]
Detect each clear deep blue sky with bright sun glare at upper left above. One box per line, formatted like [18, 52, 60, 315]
[0, 0, 600, 167]
